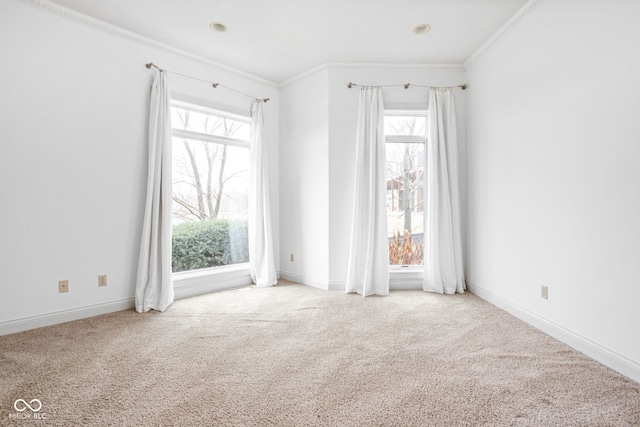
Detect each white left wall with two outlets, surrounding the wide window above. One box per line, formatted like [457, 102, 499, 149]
[0, 1, 279, 332]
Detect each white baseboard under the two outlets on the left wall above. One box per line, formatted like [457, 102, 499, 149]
[0, 298, 135, 335]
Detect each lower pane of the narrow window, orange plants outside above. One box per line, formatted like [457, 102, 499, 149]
[385, 143, 425, 265]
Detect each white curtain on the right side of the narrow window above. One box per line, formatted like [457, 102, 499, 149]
[423, 89, 465, 294]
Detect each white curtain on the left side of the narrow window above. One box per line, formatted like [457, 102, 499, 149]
[347, 87, 389, 296]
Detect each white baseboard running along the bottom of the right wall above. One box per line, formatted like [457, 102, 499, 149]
[467, 281, 640, 383]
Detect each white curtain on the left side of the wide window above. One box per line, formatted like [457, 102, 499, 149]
[135, 71, 174, 313]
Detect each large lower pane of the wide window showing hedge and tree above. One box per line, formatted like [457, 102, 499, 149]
[172, 138, 249, 272]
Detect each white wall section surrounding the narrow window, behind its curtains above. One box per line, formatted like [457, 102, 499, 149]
[328, 64, 466, 289]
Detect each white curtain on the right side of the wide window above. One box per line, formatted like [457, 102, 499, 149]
[249, 101, 278, 286]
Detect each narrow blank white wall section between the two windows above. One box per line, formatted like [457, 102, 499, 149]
[280, 69, 329, 289]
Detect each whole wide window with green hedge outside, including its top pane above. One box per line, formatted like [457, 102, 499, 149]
[171, 101, 251, 273]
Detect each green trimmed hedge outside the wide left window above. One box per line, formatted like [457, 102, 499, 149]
[171, 219, 249, 272]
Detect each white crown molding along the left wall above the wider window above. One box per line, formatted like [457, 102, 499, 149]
[15, 0, 278, 88]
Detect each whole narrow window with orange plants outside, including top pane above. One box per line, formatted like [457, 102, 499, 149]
[384, 110, 427, 266]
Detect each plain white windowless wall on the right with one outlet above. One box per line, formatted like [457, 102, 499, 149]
[466, 0, 640, 380]
